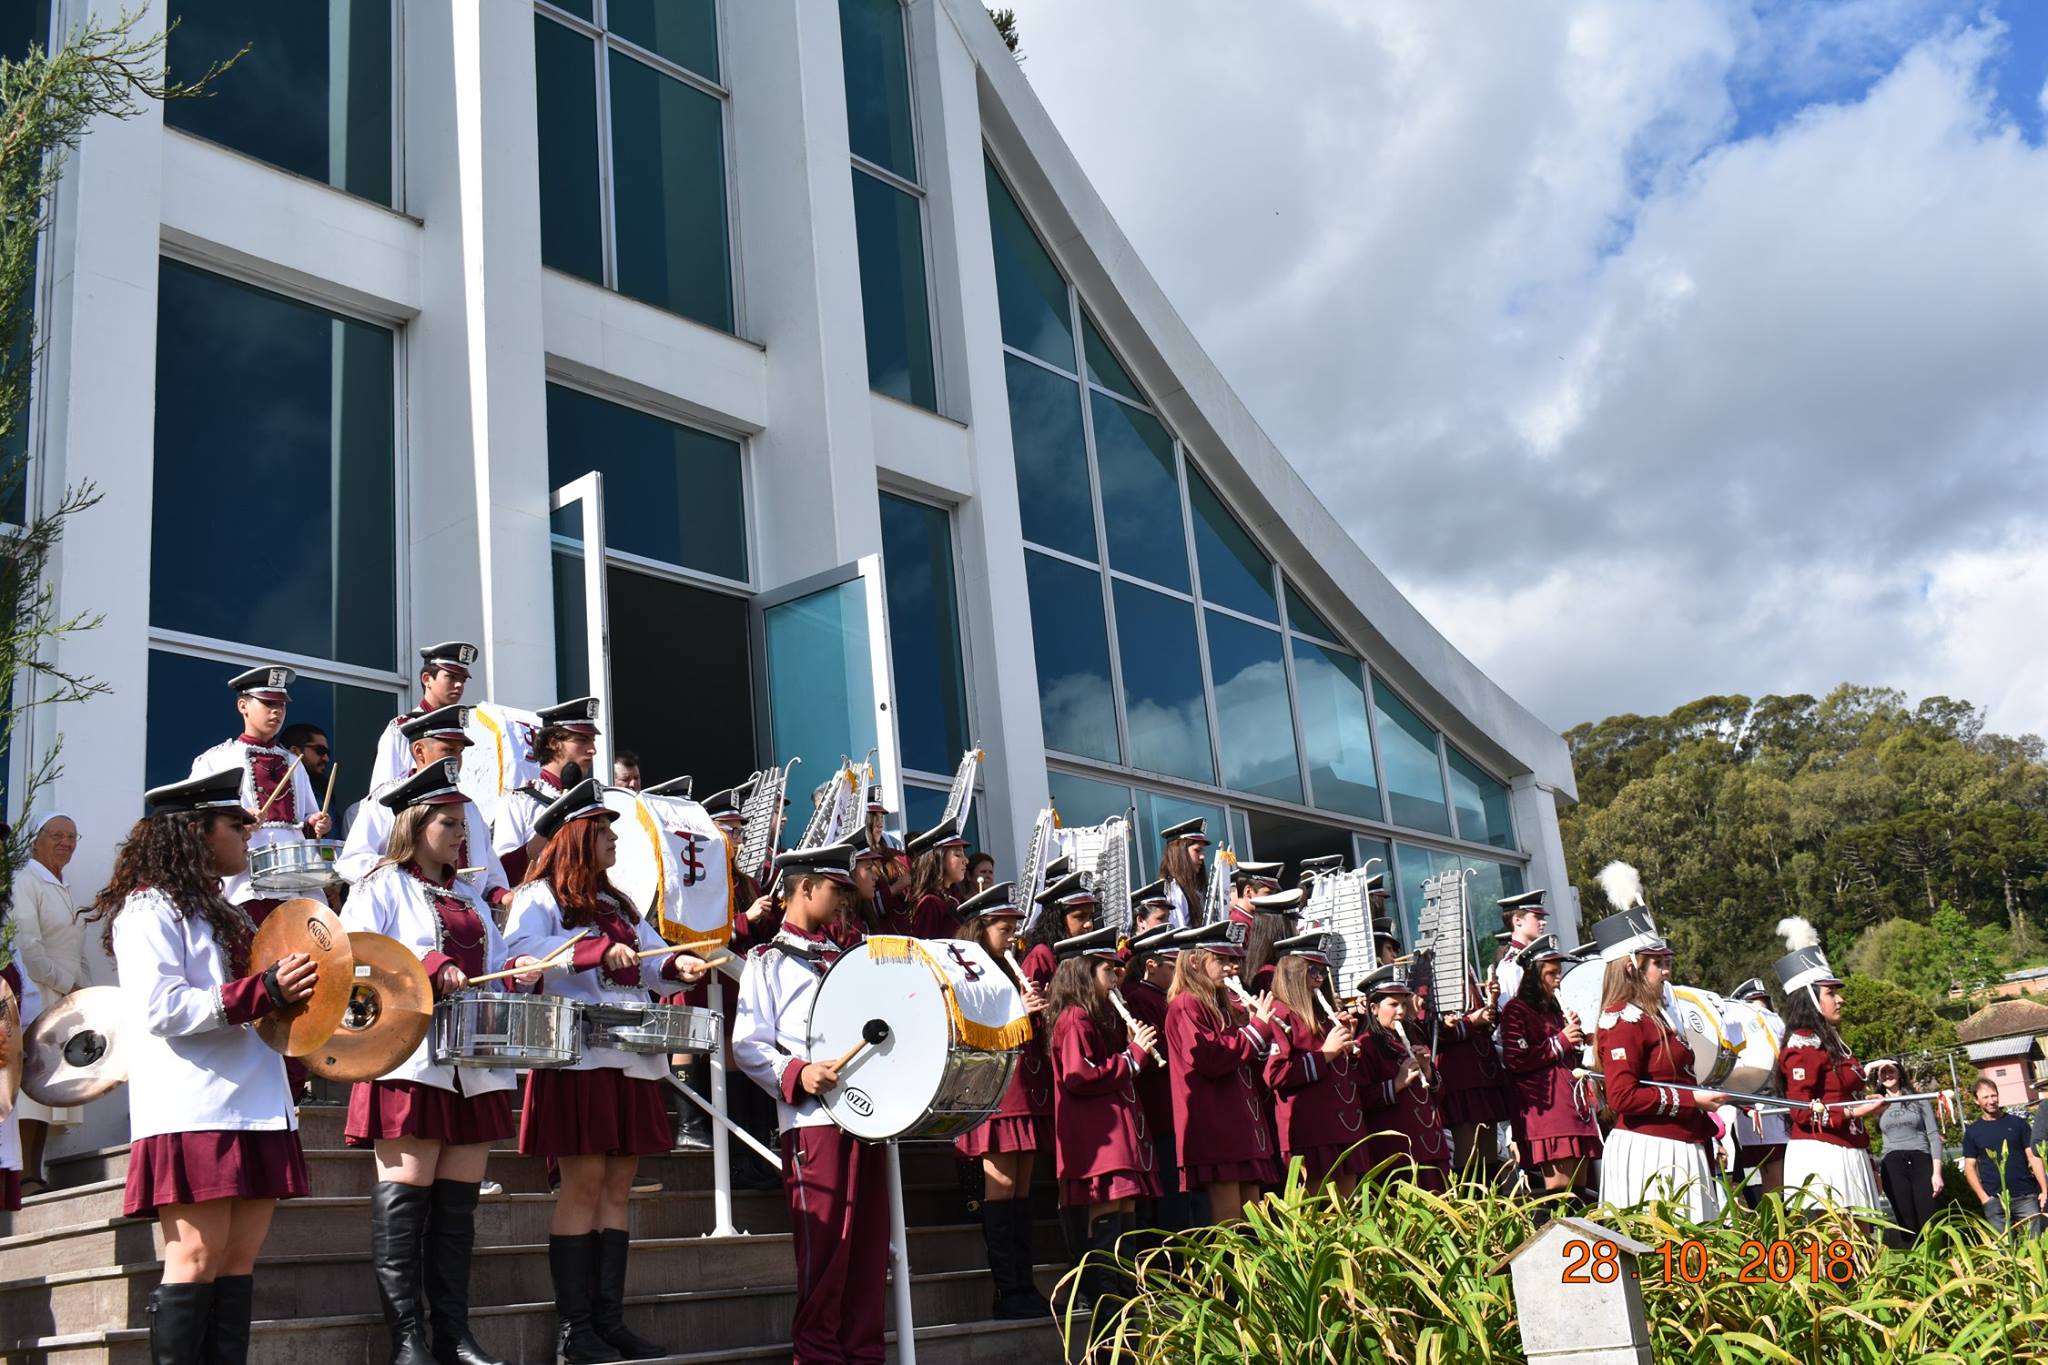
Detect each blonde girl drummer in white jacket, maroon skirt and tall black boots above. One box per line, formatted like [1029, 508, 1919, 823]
[342, 765, 539, 1365]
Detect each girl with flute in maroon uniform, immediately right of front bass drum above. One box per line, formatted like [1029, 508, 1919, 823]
[952, 882, 1053, 1318]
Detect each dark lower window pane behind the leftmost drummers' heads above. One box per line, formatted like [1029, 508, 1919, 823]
[146, 649, 399, 822]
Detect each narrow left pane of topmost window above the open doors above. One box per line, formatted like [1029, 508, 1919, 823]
[532, 14, 604, 284]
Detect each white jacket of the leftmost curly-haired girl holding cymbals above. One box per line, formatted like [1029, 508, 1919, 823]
[115, 890, 299, 1138]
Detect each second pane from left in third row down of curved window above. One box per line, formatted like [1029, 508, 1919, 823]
[1112, 579, 1217, 782]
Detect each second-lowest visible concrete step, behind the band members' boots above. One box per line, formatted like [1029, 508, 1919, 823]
[0, 1220, 1063, 1336]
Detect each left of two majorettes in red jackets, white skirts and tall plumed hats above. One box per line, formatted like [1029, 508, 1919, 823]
[1593, 905, 1726, 1224]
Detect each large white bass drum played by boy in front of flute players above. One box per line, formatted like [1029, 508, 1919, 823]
[807, 935, 1030, 1142]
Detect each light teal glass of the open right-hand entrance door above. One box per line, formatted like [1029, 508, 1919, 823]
[762, 579, 874, 839]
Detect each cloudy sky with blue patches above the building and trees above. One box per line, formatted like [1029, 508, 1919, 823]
[1012, 0, 2048, 733]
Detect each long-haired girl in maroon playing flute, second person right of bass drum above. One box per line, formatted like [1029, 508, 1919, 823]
[1051, 927, 1161, 1312]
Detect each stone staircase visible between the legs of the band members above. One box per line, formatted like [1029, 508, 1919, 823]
[0, 1103, 1061, 1365]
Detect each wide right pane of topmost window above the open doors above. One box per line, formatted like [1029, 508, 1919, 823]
[610, 51, 733, 332]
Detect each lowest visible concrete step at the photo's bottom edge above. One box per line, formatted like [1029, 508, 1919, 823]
[12, 1267, 1059, 1365]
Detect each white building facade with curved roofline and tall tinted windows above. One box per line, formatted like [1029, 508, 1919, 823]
[8, 0, 1573, 970]
